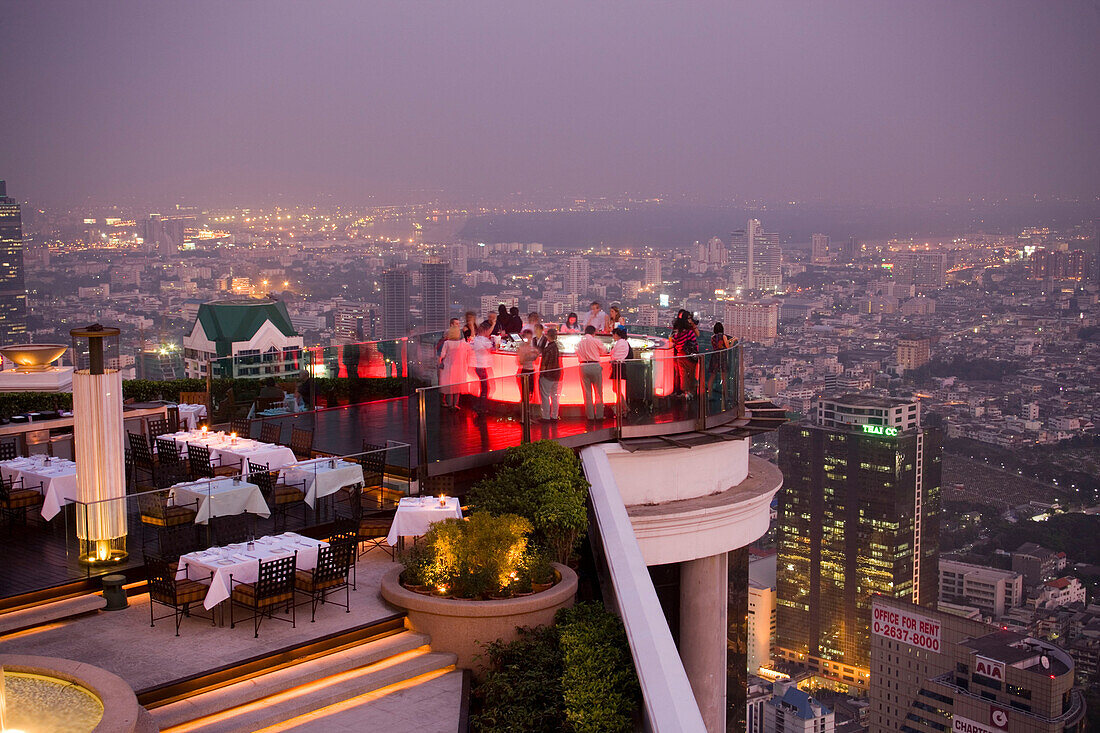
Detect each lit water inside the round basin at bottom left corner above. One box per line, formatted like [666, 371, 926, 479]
[0, 667, 103, 733]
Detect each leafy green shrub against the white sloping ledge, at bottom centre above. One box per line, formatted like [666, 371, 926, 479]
[554, 603, 641, 733]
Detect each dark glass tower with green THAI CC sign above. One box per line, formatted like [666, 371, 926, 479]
[776, 394, 942, 690]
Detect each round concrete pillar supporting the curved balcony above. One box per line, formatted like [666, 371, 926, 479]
[680, 553, 727, 733]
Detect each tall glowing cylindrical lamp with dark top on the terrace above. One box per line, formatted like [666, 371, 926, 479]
[69, 324, 127, 565]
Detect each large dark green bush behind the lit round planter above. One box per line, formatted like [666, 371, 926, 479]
[471, 440, 589, 564]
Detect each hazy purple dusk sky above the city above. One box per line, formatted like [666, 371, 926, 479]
[0, 0, 1100, 205]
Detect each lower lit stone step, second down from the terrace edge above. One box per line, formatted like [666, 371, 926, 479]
[153, 647, 457, 733]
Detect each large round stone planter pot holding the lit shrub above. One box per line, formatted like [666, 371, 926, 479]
[382, 564, 576, 672]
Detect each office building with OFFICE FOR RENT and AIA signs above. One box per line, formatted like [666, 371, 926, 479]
[870, 597, 1085, 733]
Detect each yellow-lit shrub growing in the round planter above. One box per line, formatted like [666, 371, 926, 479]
[411, 513, 531, 598]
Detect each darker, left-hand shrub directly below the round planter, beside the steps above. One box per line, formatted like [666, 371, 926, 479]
[470, 626, 565, 733]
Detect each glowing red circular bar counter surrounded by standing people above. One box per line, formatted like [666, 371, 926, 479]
[464, 333, 674, 405]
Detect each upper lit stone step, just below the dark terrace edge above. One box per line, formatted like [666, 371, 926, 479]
[151, 631, 428, 729]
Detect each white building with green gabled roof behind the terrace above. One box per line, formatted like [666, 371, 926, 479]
[184, 298, 304, 379]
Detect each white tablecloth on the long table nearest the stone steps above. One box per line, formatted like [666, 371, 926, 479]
[176, 532, 328, 610]
